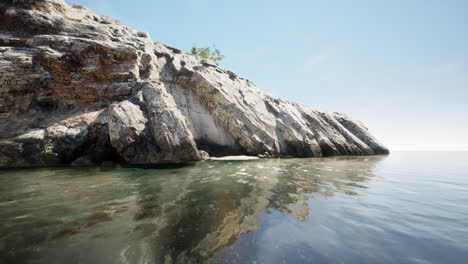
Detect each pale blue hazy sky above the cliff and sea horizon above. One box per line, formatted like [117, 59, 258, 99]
[69, 0, 468, 150]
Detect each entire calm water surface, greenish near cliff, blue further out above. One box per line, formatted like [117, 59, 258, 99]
[0, 152, 468, 264]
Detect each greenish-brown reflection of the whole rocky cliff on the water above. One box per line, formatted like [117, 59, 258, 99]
[0, 156, 384, 263]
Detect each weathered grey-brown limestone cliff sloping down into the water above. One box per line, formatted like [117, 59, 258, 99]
[0, 0, 388, 167]
